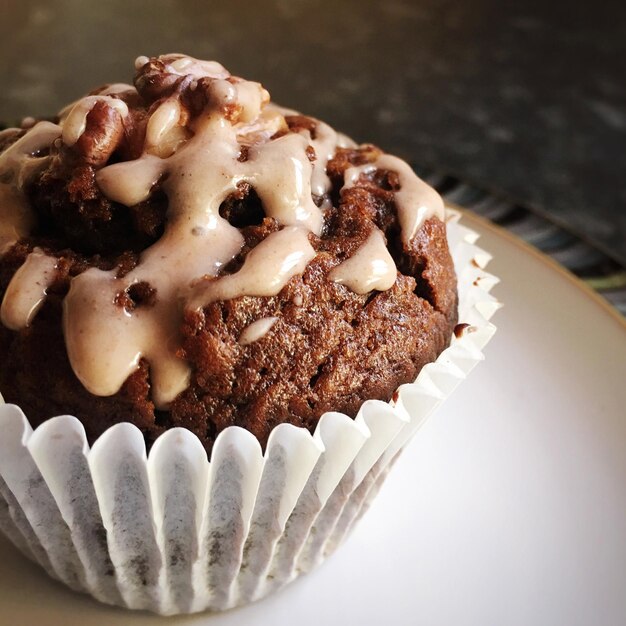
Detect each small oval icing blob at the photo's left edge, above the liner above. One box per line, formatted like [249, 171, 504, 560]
[0, 248, 57, 330]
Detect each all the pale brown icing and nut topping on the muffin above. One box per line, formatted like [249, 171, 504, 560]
[0, 54, 443, 408]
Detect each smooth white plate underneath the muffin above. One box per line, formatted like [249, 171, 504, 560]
[0, 212, 626, 626]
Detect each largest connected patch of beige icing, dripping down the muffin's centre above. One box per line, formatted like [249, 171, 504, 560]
[64, 57, 323, 407]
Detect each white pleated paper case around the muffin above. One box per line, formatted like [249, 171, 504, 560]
[0, 210, 498, 615]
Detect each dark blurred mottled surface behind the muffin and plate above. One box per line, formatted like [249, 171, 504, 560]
[0, 0, 626, 263]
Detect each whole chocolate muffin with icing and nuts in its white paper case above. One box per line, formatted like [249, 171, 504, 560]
[0, 54, 495, 614]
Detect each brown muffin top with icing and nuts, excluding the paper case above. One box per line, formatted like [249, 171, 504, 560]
[0, 55, 457, 450]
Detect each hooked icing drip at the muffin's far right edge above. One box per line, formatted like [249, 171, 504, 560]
[344, 154, 445, 244]
